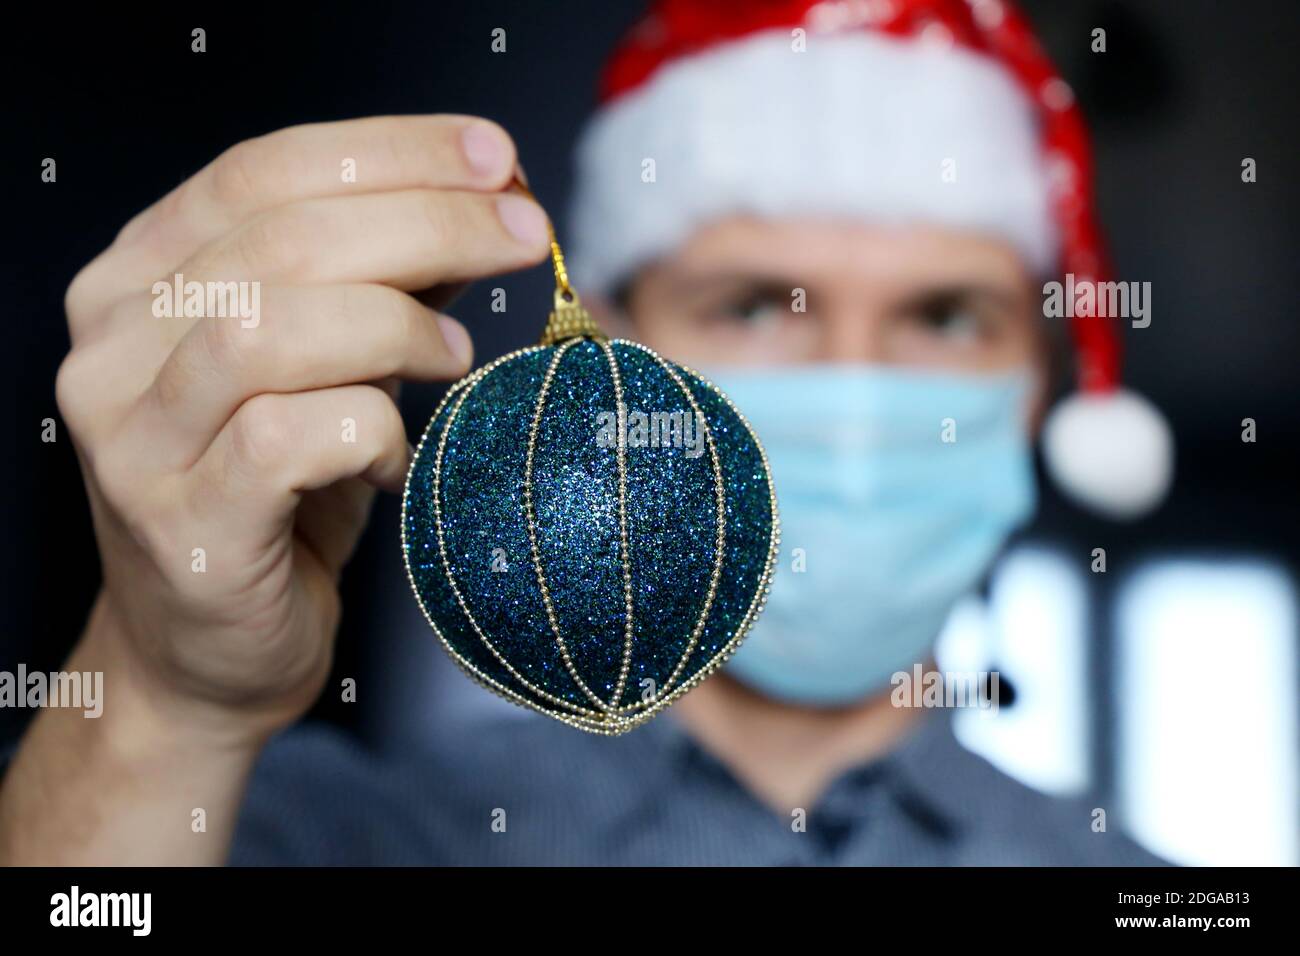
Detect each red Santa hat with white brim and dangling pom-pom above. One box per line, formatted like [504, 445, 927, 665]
[572, 0, 1173, 518]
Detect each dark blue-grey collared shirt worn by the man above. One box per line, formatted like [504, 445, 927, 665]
[231, 711, 1161, 865]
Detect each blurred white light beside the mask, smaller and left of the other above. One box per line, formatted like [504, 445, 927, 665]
[936, 548, 1088, 795]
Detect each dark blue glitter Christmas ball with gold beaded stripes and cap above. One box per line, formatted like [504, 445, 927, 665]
[402, 188, 779, 734]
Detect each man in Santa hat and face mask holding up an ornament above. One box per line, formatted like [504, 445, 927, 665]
[0, 0, 1175, 864]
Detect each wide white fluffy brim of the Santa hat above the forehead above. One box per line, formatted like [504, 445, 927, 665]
[571, 30, 1057, 293]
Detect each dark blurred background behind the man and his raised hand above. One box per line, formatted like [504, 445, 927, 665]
[0, 0, 1300, 806]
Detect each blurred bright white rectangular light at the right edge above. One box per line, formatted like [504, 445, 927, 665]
[1118, 561, 1300, 865]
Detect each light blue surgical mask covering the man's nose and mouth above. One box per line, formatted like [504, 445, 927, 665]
[702, 365, 1035, 706]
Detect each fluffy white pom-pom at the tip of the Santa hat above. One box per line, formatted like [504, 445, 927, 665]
[1043, 389, 1174, 518]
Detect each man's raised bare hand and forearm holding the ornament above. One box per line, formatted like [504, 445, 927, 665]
[0, 116, 547, 858]
